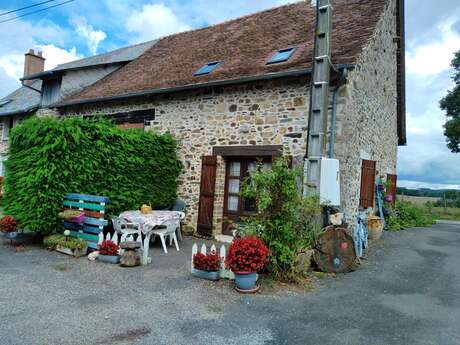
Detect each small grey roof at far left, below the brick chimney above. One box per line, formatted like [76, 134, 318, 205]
[0, 80, 42, 116]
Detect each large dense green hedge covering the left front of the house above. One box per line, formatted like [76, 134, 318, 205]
[4, 117, 182, 233]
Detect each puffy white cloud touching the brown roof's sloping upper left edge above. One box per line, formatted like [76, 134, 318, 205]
[125, 3, 191, 42]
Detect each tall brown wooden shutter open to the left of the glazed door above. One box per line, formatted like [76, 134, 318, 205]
[196, 156, 217, 235]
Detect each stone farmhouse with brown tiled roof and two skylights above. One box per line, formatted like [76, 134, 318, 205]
[0, 0, 406, 234]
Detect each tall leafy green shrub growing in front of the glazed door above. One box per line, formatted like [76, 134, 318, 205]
[241, 159, 321, 280]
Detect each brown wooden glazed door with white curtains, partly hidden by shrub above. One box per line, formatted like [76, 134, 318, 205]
[222, 157, 271, 235]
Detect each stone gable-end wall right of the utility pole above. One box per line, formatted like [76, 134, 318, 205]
[335, 0, 398, 223]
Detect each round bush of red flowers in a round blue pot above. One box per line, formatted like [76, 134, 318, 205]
[225, 236, 269, 292]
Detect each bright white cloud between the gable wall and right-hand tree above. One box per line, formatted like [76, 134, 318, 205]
[406, 20, 460, 76]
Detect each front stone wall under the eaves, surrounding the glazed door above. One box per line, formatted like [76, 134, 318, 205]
[61, 78, 309, 233]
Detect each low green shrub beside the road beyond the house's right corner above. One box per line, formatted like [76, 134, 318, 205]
[386, 201, 434, 231]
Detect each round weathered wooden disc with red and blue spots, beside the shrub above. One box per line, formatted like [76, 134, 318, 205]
[313, 225, 356, 273]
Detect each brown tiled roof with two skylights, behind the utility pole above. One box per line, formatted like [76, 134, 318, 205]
[63, 0, 387, 104]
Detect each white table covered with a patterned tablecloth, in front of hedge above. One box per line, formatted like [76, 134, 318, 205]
[120, 210, 180, 265]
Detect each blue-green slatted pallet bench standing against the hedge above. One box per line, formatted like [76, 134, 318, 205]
[62, 193, 109, 249]
